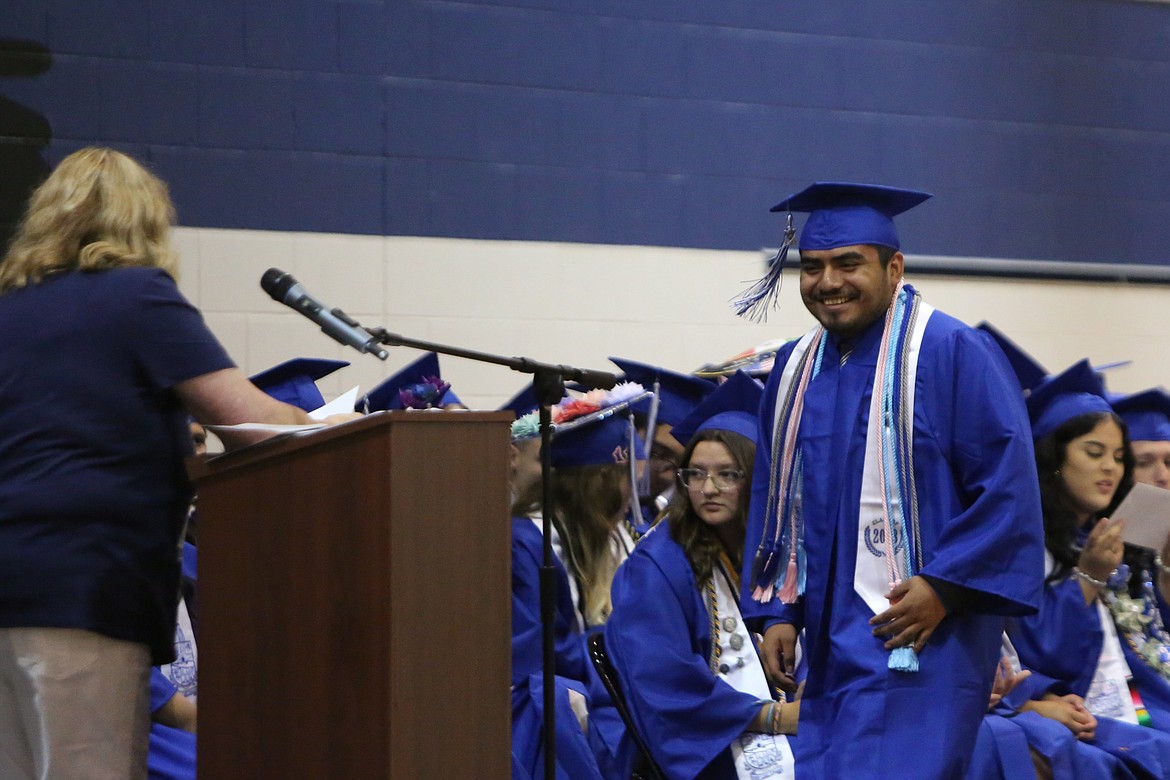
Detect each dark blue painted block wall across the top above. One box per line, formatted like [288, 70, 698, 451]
[0, 0, 1170, 264]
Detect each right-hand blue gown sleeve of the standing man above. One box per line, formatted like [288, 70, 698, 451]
[915, 327, 1044, 615]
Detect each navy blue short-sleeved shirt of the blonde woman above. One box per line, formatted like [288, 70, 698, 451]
[0, 268, 233, 664]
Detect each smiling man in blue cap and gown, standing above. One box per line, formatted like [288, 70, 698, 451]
[744, 182, 1042, 778]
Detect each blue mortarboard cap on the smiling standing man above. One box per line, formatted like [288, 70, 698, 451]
[772, 181, 931, 249]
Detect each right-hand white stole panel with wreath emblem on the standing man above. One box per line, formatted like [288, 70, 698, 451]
[853, 302, 935, 615]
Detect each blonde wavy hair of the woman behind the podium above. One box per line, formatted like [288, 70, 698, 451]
[0, 146, 179, 295]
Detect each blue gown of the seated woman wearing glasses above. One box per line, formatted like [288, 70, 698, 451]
[605, 522, 759, 780]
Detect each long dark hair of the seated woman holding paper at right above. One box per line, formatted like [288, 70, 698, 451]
[1035, 412, 1134, 582]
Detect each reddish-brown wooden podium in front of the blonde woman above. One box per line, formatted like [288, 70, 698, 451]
[191, 412, 511, 780]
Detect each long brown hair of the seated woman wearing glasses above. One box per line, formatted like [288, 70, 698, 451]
[660, 428, 756, 587]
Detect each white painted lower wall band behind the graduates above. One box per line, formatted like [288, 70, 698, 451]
[176, 228, 1170, 409]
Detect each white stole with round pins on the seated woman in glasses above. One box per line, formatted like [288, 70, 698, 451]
[711, 567, 796, 780]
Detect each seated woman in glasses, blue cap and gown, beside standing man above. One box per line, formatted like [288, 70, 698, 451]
[605, 373, 799, 779]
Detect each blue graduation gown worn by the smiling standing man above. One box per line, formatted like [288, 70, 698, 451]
[743, 311, 1044, 778]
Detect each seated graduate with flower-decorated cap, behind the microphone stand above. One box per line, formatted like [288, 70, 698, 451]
[510, 385, 646, 780]
